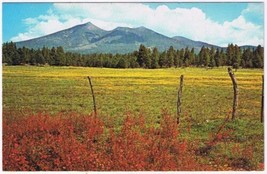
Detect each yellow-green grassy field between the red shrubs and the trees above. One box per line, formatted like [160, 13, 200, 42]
[2, 66, 264, 171]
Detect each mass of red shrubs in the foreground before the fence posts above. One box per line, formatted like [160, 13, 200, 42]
[3, 113, 212, 171]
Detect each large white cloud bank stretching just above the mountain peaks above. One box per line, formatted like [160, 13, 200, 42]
[12, 3, 264, 46]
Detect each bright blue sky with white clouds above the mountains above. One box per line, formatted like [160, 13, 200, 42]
[2, 2, 264, 46]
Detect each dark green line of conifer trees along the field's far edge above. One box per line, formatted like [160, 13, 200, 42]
[2, 42, 264, 69]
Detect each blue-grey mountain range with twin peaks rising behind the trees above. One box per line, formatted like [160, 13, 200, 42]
[16, 22, 255, 54]
